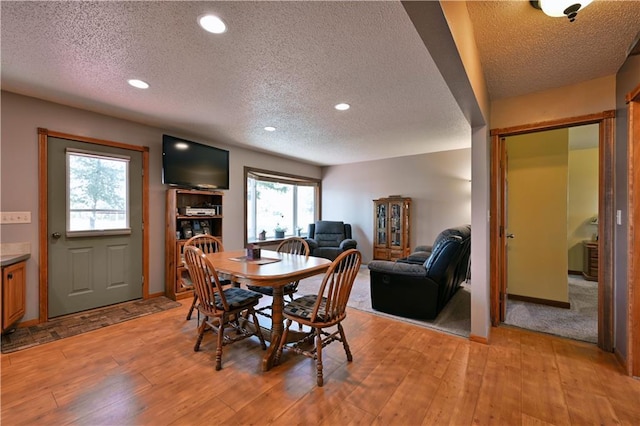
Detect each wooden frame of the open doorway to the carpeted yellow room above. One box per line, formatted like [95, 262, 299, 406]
[489, 110, 615, 352]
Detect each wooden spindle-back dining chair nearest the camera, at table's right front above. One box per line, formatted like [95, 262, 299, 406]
[275, 249, 362, 386]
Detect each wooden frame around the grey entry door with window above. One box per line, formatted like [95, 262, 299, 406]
[38, 128, 149, 323]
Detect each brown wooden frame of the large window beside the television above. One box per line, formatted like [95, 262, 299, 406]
[243, 166, 322, 247]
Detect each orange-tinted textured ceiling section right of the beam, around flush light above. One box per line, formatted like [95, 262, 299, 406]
[467, 0, 640, 100]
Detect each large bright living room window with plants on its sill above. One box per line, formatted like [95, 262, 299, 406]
[245, 168, 320, 243]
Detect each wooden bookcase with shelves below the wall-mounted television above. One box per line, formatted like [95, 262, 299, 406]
[164, 189, 223, 300]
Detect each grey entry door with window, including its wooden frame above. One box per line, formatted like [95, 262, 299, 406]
[38, 129, 149, 323]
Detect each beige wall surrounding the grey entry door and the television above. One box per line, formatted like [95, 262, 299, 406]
[0, 91, 321, 321]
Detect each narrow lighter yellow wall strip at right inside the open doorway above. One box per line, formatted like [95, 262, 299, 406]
[567, 148, 598, 271]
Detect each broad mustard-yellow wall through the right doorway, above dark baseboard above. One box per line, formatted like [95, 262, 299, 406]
[507, 129, 569, 302]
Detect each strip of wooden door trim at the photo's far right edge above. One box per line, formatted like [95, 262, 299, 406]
[626, 85, 640, 376]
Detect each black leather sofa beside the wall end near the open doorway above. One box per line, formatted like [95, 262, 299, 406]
[369, 225, 471, 319]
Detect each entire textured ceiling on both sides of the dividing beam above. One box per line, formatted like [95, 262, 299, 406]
[0, 0, 640, 165]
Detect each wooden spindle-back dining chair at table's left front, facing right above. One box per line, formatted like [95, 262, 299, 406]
[184, 246, 267, 370]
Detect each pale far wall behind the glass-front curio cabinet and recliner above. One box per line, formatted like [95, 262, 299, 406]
[322, 148, 471, 263]
